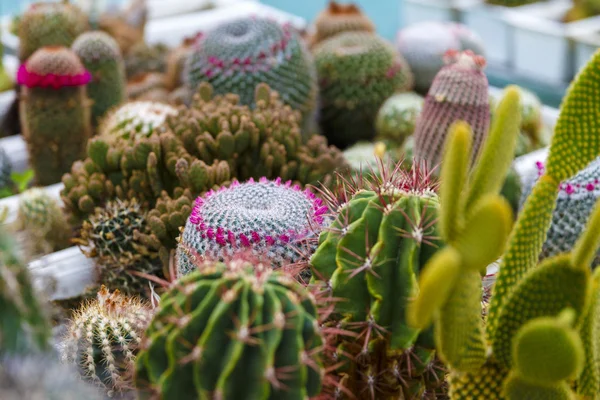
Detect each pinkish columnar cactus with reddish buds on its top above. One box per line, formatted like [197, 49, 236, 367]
[414, 51, 490, 168]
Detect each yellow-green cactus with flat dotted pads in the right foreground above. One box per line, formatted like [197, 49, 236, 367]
[408, 48, 600, 400]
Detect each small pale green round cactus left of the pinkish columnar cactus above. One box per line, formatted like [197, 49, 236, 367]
[375, 92, 424, 147]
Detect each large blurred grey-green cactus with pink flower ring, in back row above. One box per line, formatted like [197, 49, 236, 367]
[184, 17, 318, 130]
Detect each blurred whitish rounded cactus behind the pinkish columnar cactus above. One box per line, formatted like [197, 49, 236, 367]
[396, 21, 485, 94]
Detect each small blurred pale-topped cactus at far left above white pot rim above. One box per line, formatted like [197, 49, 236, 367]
[17, 188, 71, 255]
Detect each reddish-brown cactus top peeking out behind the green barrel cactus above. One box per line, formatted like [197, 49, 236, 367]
[310, 0, 375, 47]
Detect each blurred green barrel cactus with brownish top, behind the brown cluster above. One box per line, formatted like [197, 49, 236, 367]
[313, 32, 413, 148]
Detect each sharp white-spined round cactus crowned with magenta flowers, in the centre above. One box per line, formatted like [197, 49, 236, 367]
[177, 177, 328, 275]
